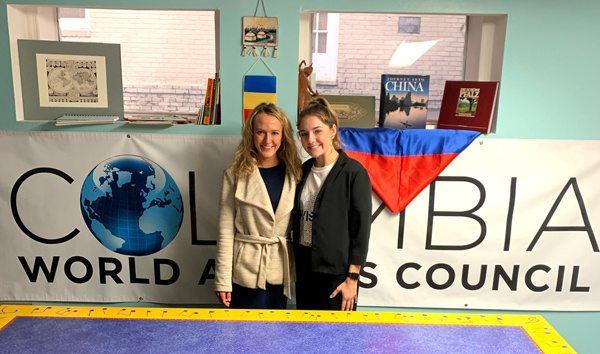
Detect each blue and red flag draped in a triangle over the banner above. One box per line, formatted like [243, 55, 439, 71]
[339, 128, 481, 213]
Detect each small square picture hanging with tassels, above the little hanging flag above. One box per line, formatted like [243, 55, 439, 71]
[242, 0, 279, 58]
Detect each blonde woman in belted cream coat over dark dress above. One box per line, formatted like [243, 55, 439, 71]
[215, 103, 302, 309]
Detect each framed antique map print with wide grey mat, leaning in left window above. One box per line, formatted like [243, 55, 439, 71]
[18, 39, 123, 120]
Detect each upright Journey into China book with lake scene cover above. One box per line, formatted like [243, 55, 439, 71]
[379, 74, 429, 130]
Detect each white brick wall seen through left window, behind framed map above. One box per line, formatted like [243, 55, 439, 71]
[63, 9, 216, 114]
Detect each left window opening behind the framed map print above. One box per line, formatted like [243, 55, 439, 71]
[8, 5, 218, 119]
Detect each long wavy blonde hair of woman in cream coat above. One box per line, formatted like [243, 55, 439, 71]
[230, 102, 302, 182]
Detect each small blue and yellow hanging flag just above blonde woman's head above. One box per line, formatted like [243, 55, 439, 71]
[243, 58, 277, 122]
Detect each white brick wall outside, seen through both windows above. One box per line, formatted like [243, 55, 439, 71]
[63, 9, 466, 114]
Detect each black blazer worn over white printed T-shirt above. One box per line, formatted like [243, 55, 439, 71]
[293, 150, 371, 274]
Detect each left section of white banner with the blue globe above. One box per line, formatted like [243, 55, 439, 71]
[0, 132, 240, 304]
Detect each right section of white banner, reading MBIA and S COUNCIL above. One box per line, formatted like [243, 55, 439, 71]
[359, 139, 600, 310]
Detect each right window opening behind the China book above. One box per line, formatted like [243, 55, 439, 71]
[299, 11, 506, 130]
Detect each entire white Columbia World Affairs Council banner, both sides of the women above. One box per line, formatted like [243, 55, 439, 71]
[0, 131, 600, 310]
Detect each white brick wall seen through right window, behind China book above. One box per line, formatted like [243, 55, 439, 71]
[316, 13, 466, 116]
